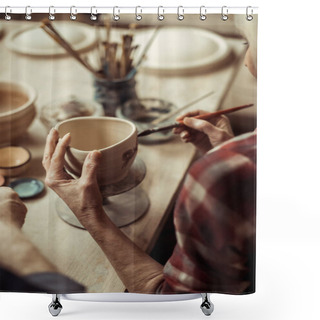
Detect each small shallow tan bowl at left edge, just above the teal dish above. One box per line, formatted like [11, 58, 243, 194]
[0, 146, 31, 177]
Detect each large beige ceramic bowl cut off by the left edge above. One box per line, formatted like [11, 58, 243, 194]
[0, 82, 36, 145]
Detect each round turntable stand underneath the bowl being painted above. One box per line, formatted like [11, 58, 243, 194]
[56, 156, 149, 229]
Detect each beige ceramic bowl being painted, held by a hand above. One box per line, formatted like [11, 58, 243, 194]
[56, 117, 138, 186]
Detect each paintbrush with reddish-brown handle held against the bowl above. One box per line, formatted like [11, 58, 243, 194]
[138, 103, 253, 137]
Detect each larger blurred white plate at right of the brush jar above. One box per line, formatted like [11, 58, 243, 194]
[135, 27, 231, 75]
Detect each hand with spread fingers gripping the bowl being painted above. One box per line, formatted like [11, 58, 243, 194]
[42, 129, 103, 228]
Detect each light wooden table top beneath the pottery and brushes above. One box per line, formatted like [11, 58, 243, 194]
[0, 21, 252, 292]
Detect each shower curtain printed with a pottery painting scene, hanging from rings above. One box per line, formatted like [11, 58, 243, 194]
[0, 7, 258, 294]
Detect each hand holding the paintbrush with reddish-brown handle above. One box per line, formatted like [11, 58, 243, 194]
[173, 110, 234, 153]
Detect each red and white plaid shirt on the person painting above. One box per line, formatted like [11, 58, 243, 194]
[157, 132, 256, 294]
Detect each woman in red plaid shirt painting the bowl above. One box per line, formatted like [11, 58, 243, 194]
[43, 17, 256, 294]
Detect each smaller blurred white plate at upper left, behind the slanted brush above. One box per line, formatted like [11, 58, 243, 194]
[6, 22, 96, 56]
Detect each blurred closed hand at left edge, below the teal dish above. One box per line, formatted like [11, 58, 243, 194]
[0, 187, 27, 229]
